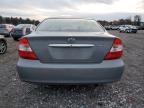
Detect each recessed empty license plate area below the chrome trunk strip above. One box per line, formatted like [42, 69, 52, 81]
[48, 47, 94, 60]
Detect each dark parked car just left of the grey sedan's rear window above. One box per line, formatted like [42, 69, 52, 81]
[12, 24, 36, 40]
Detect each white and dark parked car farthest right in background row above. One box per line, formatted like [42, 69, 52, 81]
[119, 25, 138, 33]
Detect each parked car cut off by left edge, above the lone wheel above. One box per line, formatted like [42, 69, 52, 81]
[0, 24, 14, 36]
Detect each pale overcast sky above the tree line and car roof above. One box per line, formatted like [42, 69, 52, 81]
[0, 0, 144, 21]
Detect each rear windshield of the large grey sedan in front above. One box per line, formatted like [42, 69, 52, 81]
[37, 19, 104, 32]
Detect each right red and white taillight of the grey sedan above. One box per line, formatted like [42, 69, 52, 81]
[105, 38, 123, 60]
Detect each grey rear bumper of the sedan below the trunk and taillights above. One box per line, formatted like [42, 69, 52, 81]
[17, 58, 124, 84]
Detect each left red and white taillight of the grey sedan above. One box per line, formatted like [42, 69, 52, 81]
[18, 37, 37, 60]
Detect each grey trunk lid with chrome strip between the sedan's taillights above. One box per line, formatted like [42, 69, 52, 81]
[28, 33, 114, 63]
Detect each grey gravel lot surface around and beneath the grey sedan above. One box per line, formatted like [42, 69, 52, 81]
[0, 31, 144, 108]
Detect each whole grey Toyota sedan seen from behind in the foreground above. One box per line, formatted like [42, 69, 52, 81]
[17, 18, 124, 84]
